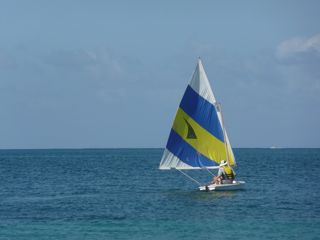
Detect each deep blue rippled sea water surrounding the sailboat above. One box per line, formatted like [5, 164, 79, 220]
[0, 149, 320, 240]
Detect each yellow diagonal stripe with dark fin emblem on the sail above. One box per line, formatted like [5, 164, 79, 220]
[172, 108, 234, 165]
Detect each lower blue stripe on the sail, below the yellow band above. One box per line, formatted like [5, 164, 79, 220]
[166, 129, 217, 167]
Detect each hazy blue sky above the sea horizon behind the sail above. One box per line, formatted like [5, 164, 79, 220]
[0, 0, 320, 149]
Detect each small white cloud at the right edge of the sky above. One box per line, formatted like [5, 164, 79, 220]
[276, 33, 320, 59]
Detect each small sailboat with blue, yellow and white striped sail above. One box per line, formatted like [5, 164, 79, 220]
[159, 58, 245, 191]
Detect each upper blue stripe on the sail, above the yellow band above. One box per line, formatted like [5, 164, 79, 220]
[180, 85, 224, 142]
